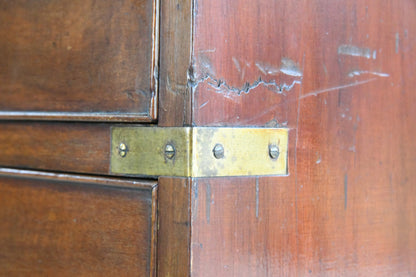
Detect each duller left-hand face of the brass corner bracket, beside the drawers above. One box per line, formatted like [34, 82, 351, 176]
[111, 126, 191, 176]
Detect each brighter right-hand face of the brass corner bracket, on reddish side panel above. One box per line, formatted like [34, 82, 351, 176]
[191, 128, 288, 177]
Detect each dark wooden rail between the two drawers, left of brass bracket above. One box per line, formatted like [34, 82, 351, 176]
[0, 121, 111, 174]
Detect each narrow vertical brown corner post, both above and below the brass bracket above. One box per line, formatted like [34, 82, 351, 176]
[157, 0, 193, 277]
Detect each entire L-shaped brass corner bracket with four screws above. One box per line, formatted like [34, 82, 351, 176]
[110, 126, 288, 177]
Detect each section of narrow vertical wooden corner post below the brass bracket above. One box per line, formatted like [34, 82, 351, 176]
[157, 177, 191, 277]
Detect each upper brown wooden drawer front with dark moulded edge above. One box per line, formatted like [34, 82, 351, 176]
[0, 0, 158, 122]
